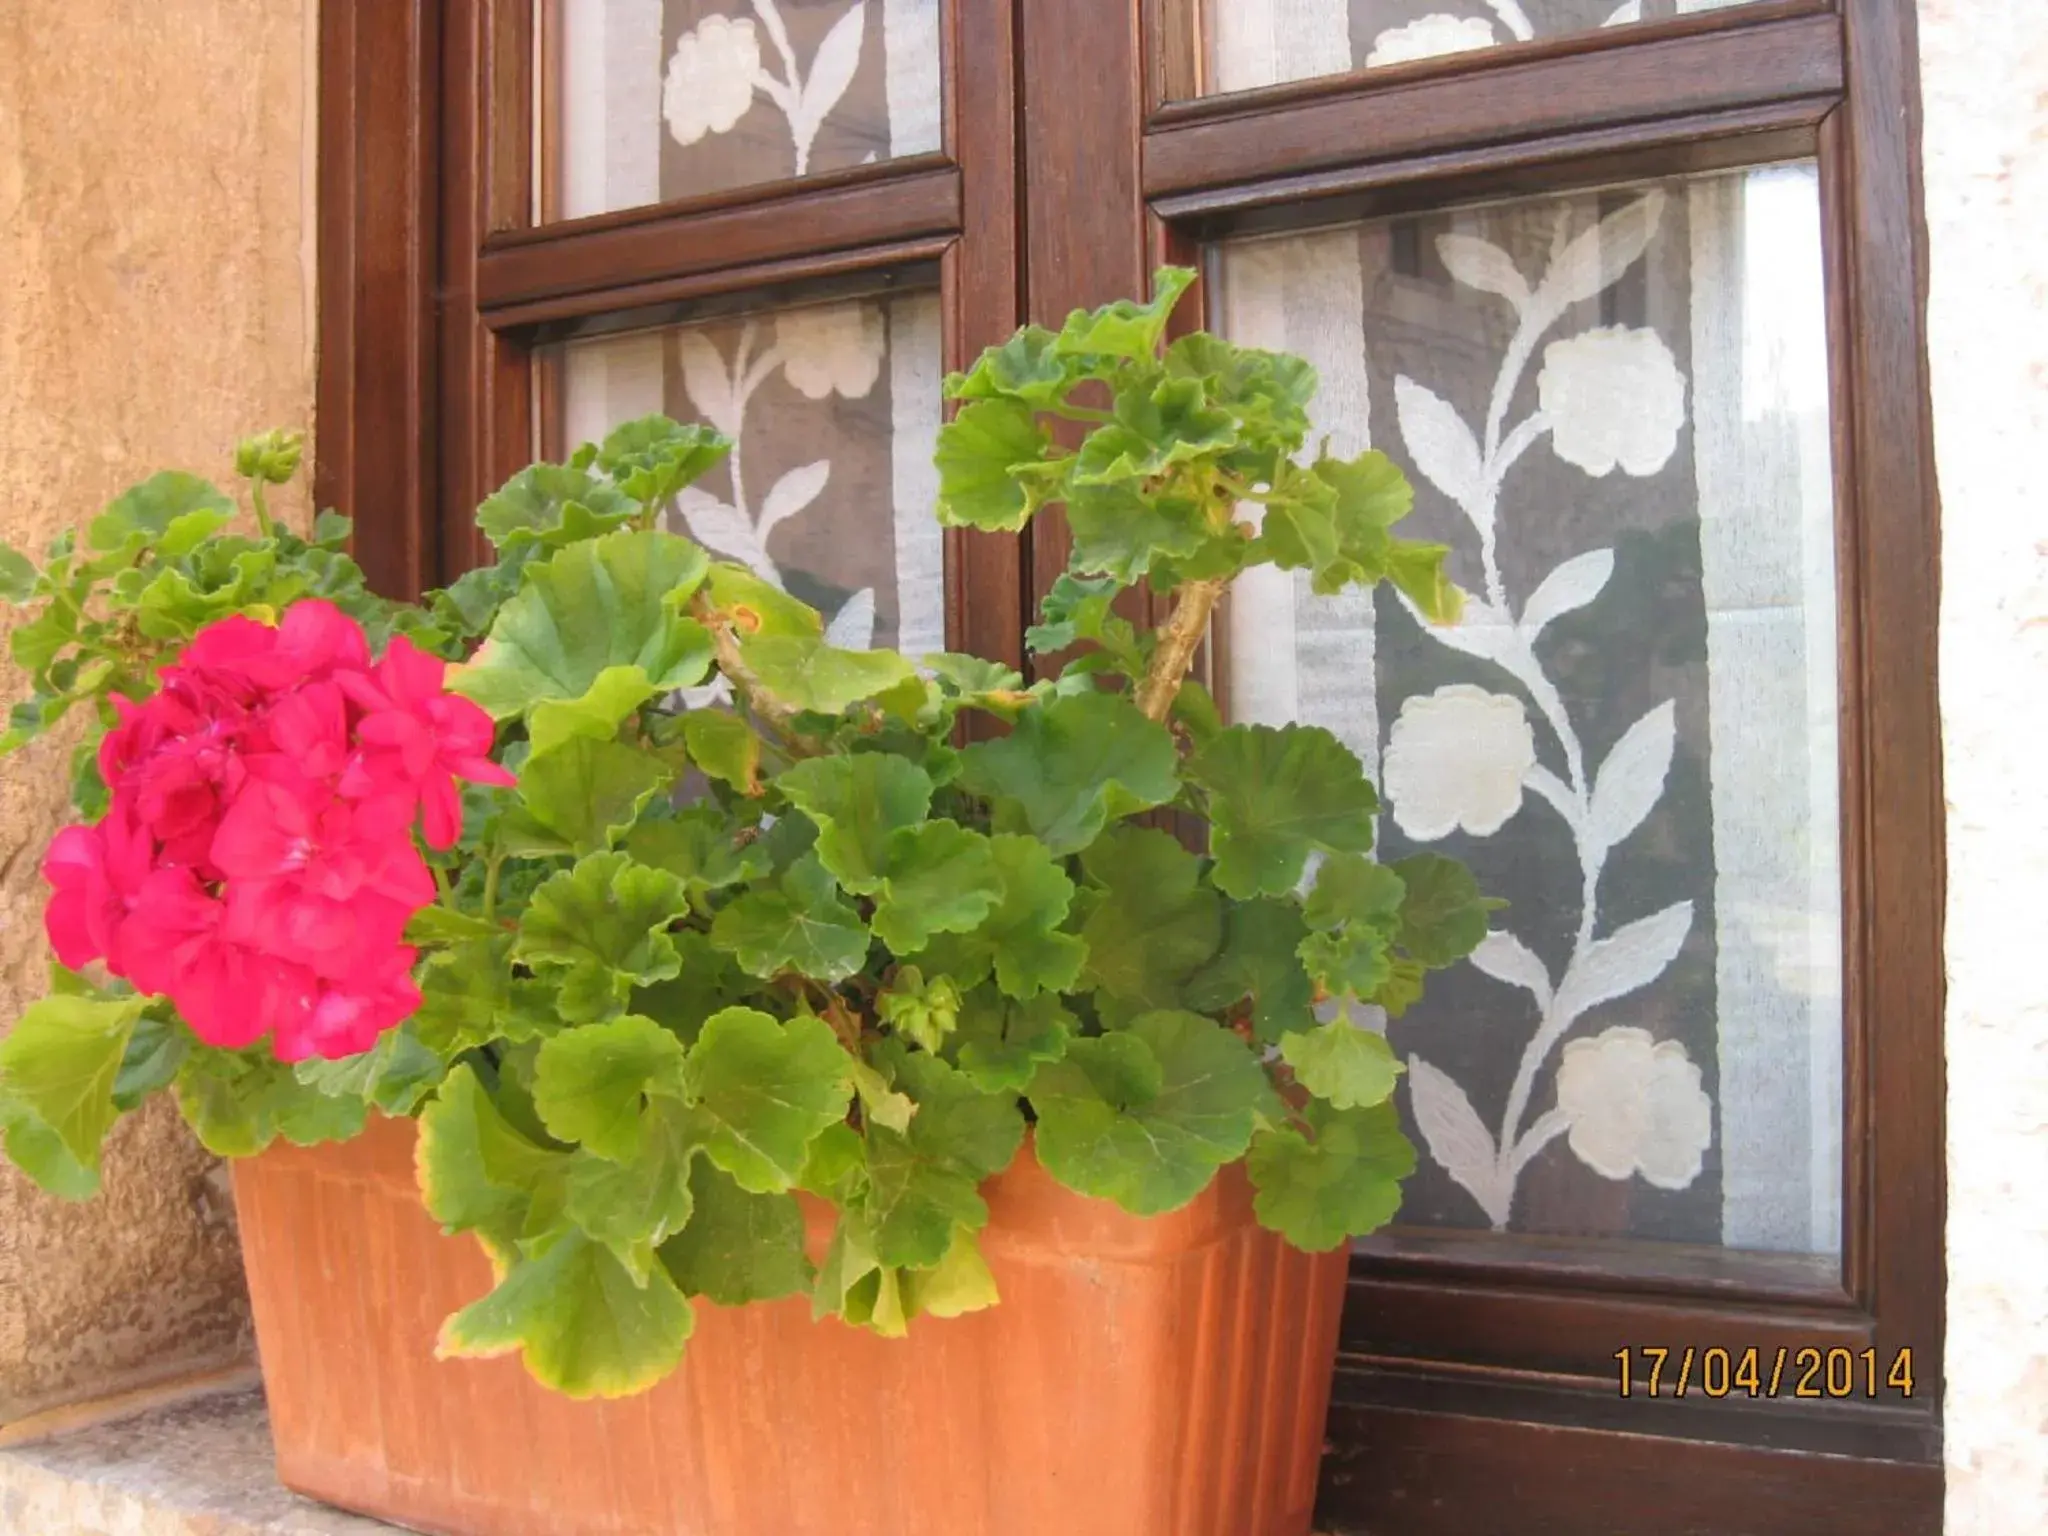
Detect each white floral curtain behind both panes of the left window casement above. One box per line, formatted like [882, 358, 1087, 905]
[557, 0, 946, 655]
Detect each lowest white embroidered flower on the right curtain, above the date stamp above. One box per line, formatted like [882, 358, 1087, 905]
[1556, 1024, 1714, 1190]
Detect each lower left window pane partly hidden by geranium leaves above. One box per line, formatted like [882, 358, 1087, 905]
[559, 293, 946, 655]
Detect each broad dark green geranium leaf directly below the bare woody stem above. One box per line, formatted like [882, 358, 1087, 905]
[1188, 725, 1378, 899]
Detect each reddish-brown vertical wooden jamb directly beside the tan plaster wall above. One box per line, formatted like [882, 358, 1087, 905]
[313, 0, 440, 598]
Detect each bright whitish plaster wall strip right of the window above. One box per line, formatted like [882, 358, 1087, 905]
[1919, 0, 2048, 1536]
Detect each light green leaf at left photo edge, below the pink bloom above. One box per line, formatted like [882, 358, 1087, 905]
[0, 995, 143, 1198]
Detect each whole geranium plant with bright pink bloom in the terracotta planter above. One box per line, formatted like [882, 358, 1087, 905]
[0, 268, 1489, 1395]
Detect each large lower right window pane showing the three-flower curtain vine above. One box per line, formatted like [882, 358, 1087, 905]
[1214, 166, 1841, 1255]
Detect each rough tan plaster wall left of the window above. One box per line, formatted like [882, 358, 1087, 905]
[0, 0, 313, 1421]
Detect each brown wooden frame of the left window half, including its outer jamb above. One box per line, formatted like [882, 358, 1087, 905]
[313, 0, 1026, 662]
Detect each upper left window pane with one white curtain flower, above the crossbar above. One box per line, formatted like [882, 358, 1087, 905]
[557, 0, 940, 219]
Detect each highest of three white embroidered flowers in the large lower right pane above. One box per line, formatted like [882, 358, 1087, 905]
[1536, 326, 1686, 479]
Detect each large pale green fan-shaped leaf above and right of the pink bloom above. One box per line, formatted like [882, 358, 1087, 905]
[449, 530, 713, 719]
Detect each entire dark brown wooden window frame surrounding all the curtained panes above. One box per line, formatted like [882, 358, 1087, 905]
[315, 0, 1946, 1536]
